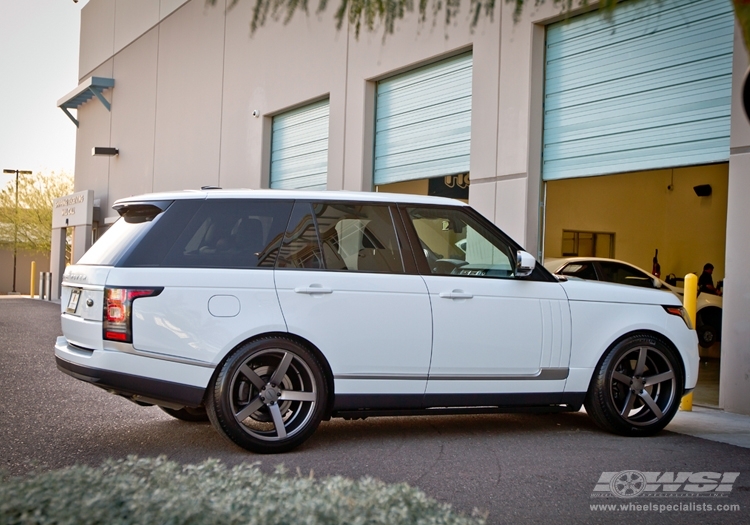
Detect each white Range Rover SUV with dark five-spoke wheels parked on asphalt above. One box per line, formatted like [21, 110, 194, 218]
[55, 189, 698, 453]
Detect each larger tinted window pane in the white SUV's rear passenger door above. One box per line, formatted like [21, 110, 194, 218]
[313, 203, 404, 273]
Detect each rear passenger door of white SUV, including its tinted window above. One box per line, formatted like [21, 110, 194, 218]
[275, 201, 432, 409]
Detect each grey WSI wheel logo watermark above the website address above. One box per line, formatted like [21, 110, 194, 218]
[591, 470, 740, 499]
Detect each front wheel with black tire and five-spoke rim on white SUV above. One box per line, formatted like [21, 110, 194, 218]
[584, 334, 685, 436]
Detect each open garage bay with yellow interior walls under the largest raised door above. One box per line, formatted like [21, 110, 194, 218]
[544, 163, 729, 405]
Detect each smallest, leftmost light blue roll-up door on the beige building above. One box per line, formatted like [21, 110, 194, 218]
[271, 100, 330, 190]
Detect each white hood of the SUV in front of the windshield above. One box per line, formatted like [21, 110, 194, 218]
[560, 279, 682, 306]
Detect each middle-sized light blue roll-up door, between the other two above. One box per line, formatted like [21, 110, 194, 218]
[374, 53, 472, 185]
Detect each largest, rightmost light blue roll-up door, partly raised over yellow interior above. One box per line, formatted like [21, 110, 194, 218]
[542, 0, 734, 180]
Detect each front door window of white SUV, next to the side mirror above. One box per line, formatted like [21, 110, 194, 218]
[408, 208, 515, 277]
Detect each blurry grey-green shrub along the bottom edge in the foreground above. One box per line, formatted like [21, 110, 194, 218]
[0, 456, 484, 525]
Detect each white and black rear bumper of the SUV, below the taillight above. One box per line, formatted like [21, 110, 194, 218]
[55, 337, 213, 407]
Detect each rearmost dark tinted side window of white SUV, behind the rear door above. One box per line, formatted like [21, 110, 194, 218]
[162, 199, 292, 268]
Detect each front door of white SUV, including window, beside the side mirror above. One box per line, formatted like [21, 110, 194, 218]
[405, 207, 571, 404]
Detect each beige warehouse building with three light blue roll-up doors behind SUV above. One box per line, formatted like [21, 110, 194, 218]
[59, 0, 750, 413]
